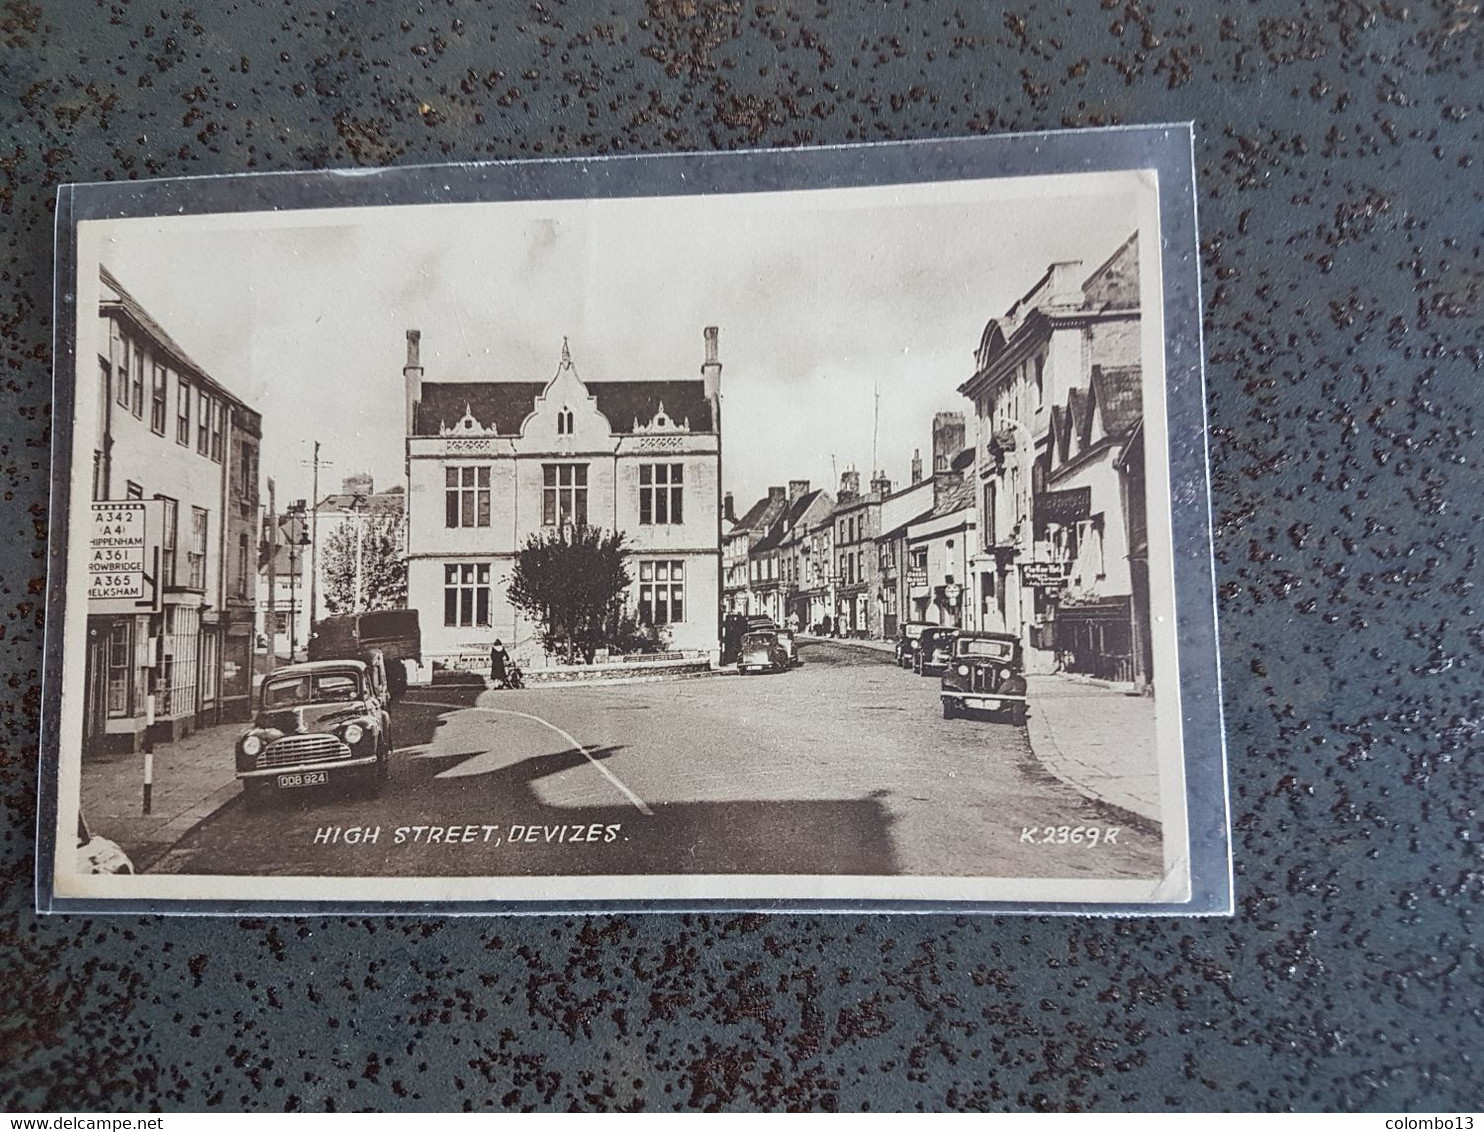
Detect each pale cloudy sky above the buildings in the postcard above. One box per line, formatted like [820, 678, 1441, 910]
[80, 174, 1144, 513]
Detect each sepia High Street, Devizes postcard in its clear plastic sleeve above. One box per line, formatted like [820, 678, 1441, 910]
[39, 128, 1230, 914]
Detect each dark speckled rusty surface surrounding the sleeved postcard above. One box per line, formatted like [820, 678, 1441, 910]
[0, 0, 1484, 1110]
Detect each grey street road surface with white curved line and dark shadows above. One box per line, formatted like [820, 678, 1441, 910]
[151, 642, 1160, 878]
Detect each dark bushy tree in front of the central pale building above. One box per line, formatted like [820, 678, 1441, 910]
[506, 525, 632, 665]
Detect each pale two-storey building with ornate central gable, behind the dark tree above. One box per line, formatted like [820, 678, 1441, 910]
[404, 326, 721, 666]
